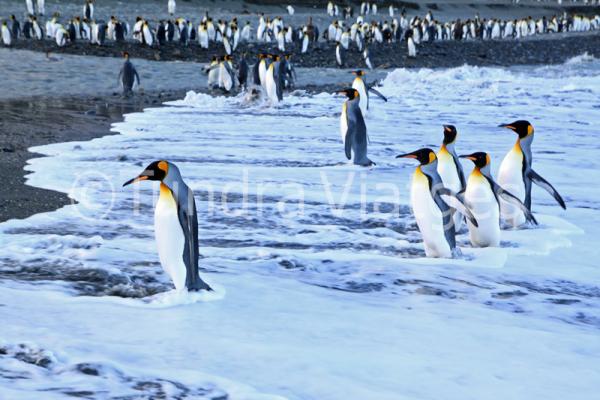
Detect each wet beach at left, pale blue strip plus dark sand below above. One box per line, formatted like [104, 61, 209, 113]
[0, 49, 385, 222]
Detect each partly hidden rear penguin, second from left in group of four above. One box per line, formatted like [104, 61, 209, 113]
[437, 125, 465, 231]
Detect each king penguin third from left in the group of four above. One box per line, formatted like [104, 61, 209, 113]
[460, 152, 537, 247]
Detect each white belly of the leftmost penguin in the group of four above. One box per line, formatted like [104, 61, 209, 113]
[410, 170, 452, 258]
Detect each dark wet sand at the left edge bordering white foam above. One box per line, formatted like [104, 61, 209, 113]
[0, 90, 198, 222]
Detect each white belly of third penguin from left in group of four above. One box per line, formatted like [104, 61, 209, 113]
[465, 172, 500, 247]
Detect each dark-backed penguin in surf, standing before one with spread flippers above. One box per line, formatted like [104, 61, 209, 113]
[337, 88, 375, 167]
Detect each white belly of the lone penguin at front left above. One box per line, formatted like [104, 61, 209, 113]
[154, 188, 186, 290]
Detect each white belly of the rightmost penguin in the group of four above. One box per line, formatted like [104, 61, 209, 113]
[498, 148, 526, 227]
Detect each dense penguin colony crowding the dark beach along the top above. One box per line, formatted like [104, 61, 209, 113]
[0, 0, 600, 65]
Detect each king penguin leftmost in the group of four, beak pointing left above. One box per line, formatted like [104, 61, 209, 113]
[396, 148, 478, 258]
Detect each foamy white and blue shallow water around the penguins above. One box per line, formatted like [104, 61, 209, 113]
[0, 57, 600, 399]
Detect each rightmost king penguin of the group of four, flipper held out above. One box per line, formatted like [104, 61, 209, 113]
[498, 120, 567, 227]
